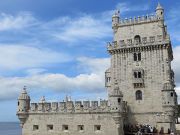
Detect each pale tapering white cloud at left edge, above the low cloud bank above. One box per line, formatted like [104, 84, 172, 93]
[0, 45, 72, 70]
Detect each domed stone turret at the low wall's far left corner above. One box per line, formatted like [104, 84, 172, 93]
[17, 86, 30, 127]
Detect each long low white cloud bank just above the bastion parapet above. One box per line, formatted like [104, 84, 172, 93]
[0, 57, 109, 100]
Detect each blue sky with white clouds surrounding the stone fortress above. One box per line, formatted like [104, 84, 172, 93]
[0, 0, 180, 121]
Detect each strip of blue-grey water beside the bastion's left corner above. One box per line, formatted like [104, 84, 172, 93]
[0, 122, 21, 135]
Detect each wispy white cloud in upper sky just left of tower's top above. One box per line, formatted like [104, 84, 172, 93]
[50, 15, 112, 43]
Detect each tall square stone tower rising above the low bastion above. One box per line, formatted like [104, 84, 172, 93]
[105, 4, 177, 132]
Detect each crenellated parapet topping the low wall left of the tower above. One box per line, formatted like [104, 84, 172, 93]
[29, 100, 114, 113]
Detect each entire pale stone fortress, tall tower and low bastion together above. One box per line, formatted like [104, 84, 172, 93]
[17, 4, 177, 135]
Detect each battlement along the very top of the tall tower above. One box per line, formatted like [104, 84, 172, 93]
[118, 14, 162, 27]
